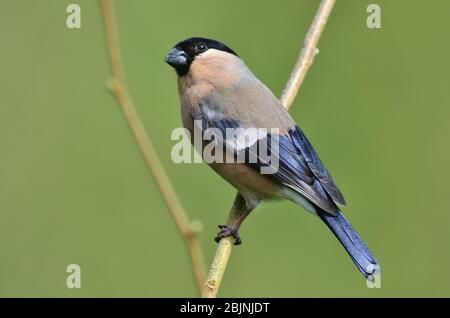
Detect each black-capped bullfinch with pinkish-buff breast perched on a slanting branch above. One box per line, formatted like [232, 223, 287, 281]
[165, 37, 380, 278]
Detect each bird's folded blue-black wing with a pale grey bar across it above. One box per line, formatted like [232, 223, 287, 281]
[194, 104, 345, 215]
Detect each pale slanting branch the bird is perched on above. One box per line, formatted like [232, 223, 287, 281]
[202, 0, 336, 298]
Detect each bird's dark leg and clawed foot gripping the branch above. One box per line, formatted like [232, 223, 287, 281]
[214, 193, 256, 245]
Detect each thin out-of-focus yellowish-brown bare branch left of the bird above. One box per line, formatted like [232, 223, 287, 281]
[100, 0, 205, 293]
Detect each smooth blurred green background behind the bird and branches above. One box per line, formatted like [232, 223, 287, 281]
[0, 0, 450, 297]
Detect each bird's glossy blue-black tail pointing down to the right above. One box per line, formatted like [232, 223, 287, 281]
[317, 209, 380, 278]
